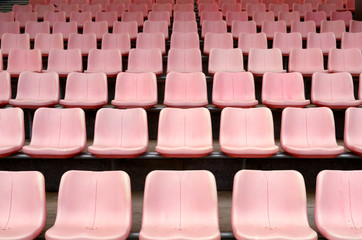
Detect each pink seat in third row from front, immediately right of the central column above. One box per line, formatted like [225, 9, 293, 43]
[212, 72, 258, 108]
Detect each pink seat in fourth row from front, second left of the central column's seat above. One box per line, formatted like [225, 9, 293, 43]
[84, 49, 122, 77]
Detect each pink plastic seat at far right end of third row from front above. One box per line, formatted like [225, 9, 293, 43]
[311, 72, 362, 109]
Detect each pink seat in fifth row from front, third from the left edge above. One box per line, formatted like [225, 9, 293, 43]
[68, 33, 97, 56]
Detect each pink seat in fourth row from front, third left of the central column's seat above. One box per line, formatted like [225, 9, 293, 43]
[45, 48, 83, 77]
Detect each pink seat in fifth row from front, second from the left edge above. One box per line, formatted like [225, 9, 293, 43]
[34, 33, 64, 56]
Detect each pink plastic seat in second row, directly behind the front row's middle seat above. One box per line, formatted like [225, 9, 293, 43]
[155, 108, 213, 158]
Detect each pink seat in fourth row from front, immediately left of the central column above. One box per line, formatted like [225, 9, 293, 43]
[127, 48, 163, 75]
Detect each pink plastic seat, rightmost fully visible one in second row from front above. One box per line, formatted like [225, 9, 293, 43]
[280, 107, 344, 158]
